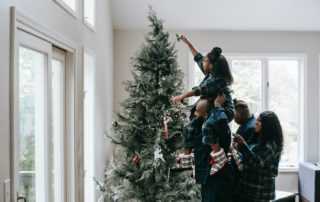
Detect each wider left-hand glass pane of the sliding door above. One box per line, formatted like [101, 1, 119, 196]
[19, 47, 45, 202]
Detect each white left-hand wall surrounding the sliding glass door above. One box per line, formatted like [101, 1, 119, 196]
[0, 0, 113, 201]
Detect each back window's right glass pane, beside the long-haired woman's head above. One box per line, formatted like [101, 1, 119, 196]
[269, 60, 300, 166]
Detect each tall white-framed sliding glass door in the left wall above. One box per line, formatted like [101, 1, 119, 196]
[17, 31, 66, 202]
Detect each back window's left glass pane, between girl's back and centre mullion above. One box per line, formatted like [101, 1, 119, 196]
[231, 60, 262, 132]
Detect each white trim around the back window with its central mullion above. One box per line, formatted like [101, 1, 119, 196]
[188, 52, 308, 172]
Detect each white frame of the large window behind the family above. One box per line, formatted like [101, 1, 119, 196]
[188, 53, 307, 172]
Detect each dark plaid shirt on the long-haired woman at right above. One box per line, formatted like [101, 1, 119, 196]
[236, 142, 281, 202]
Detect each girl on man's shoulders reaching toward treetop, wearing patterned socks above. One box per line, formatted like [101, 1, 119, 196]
[172, 35, 234, 175]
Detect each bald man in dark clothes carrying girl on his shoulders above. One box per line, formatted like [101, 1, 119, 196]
[180, 99, 234, 202]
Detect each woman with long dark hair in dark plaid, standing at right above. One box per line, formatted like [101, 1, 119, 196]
[233, 111, 283, 202]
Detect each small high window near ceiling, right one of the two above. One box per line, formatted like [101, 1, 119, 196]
[83, 0, 96, 31]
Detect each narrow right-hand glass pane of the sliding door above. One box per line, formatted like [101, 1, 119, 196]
[51, 60, 64, 202]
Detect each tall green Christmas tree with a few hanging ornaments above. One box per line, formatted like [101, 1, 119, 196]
[98, 8, 199, 202]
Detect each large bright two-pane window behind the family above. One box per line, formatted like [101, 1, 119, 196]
[191, 55, 304, 168]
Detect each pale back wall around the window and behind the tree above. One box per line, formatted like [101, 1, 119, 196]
[113, 30, 320, 192]
